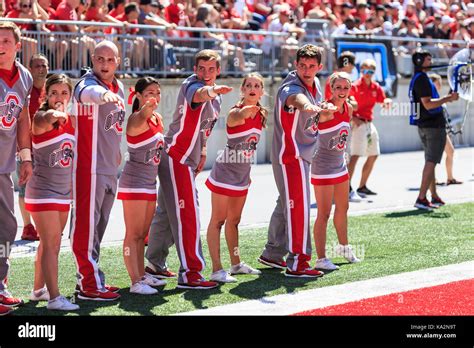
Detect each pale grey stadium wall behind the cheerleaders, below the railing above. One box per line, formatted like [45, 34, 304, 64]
[122, 79, 474, 169]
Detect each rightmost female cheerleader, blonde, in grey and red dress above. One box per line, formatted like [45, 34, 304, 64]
[311, 72, 360, 271]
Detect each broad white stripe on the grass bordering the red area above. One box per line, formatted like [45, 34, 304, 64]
[177, 261, 474, 315]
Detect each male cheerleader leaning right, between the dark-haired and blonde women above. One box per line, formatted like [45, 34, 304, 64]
[146, 50, 232, 289]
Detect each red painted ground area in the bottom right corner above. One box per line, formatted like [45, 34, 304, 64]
[294, 279, 474, 315]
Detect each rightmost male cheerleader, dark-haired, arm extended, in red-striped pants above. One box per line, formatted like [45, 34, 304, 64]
[258, 44, 335, 278]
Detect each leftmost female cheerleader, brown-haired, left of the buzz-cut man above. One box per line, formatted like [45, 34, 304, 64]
[25, 74, 79, 311]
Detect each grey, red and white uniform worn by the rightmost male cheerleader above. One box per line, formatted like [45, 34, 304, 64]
[262, 71, 322, 271]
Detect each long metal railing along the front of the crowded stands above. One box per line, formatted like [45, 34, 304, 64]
[0, 18, 466, 77]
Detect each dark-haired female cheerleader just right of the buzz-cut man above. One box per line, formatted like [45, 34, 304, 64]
[117, 77, 166, 295]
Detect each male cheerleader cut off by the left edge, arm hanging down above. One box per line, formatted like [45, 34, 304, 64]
[0, 22, 33, 316]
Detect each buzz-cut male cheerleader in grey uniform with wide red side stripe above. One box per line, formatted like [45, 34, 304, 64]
[71, 41, 125, 301]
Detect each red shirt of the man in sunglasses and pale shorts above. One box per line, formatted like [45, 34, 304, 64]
[350, 77, 386, 121]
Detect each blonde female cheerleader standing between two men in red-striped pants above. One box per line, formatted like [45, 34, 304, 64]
[206, 73, 267, 283]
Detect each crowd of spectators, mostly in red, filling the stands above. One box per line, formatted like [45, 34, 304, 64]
[0, 0, 474, 72]
